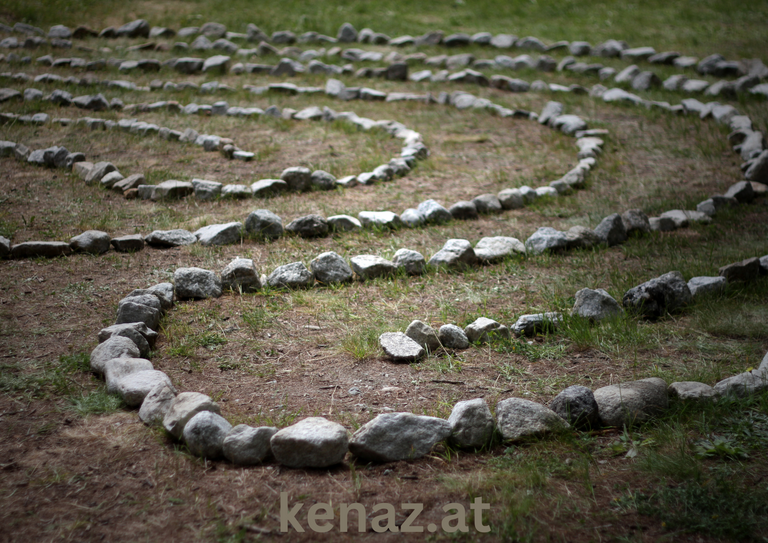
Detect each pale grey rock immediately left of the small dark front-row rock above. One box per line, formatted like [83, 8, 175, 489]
[496, 398, 568, 441]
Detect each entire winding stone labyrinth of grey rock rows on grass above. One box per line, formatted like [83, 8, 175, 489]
[0, 20, 768, 468]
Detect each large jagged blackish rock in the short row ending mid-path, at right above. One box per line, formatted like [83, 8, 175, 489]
[622, 271, 692, 319]
